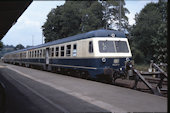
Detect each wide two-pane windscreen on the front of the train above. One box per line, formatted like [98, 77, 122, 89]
[99, 40, 129, 53]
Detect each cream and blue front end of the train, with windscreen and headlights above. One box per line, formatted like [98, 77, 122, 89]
[94, 37, 132, 81]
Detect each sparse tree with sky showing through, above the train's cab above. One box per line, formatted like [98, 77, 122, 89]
[102, 0, 130, 31]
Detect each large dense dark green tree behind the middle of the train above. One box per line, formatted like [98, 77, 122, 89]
[42, 1, 104, 42]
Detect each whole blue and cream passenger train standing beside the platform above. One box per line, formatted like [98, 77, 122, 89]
[4, 30, 132, 78]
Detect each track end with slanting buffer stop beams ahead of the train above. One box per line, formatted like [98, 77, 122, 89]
[111, 63, 168, 97]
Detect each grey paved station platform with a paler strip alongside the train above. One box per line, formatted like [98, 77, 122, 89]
[0, 63, 167, 113]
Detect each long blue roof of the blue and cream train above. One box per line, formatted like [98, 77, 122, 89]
[4, 29, 126, 53]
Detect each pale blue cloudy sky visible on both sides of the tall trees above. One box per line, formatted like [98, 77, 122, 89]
[1, 0, 158, 47]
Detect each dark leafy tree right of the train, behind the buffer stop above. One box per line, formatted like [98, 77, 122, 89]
[131, 1, 167, 62]
